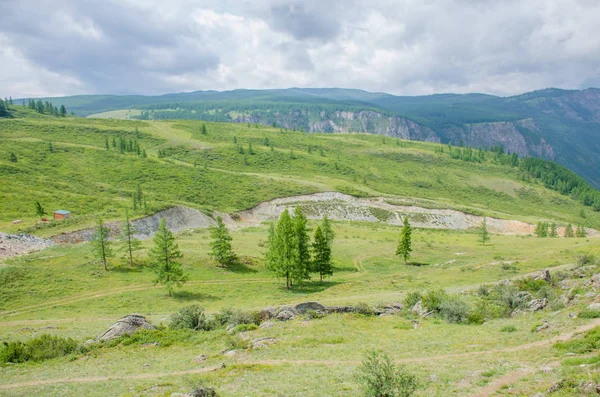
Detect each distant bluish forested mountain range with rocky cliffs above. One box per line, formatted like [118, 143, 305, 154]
[27, 88, 600, 187]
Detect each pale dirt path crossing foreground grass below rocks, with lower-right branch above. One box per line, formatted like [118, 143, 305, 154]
[0, 319, 600, 390]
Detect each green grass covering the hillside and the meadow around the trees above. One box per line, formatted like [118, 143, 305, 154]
[0, 106, 600, 397]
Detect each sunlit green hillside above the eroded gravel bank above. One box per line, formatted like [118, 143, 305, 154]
[0, 106, 600, 234]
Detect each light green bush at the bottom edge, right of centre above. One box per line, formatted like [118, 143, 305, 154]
[355, 351, 419, 397]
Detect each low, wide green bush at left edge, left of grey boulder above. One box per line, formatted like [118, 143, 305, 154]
[0, 334, 79, 363]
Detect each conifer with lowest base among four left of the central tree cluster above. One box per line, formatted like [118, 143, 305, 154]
[150, 218, 188, 296]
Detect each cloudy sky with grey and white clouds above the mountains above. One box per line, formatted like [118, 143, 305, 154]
[0, 0, 600, 97]
